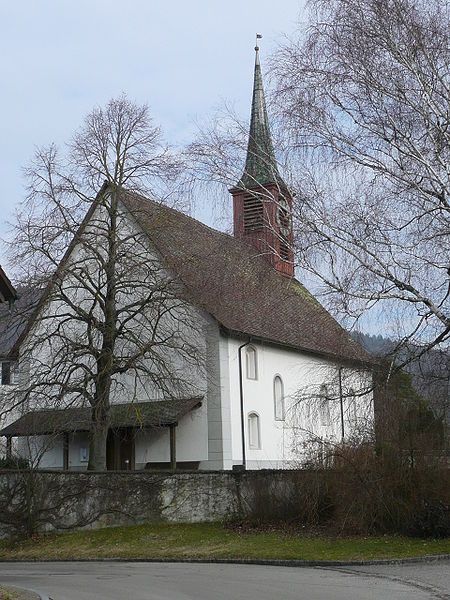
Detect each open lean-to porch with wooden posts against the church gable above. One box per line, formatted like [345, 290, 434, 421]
[0, 397, 202, 471]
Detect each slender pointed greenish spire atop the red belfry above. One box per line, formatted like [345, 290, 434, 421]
[238, 34, 286, 188]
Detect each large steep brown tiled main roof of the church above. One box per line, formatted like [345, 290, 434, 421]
[122, 193, 373, 363]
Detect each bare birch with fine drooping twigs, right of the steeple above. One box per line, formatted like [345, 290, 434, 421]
[273, 0, 450, 362]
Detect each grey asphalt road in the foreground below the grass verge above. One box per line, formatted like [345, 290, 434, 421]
[0, 561, 450, 600]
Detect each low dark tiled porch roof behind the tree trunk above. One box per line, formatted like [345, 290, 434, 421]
[0, 398, 202, 436]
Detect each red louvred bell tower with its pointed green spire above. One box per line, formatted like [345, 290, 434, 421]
[230, 34, 294, 277]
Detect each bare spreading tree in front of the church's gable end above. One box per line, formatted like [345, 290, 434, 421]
[3, 97, 202, 470]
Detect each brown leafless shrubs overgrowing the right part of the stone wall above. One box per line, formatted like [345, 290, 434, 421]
[232, 445, 450, 538]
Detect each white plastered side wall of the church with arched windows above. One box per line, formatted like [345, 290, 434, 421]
[222, 338, 373, 468]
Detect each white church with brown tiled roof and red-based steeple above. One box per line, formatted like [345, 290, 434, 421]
[0, 47, 373, 470]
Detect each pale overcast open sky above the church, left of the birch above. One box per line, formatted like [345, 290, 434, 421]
[0, 0, 303, 259]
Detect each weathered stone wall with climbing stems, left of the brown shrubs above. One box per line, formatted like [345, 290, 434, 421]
[0, 471, 310, 536]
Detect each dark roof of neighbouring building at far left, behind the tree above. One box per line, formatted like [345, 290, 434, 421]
[0, 290, 42, 358]
